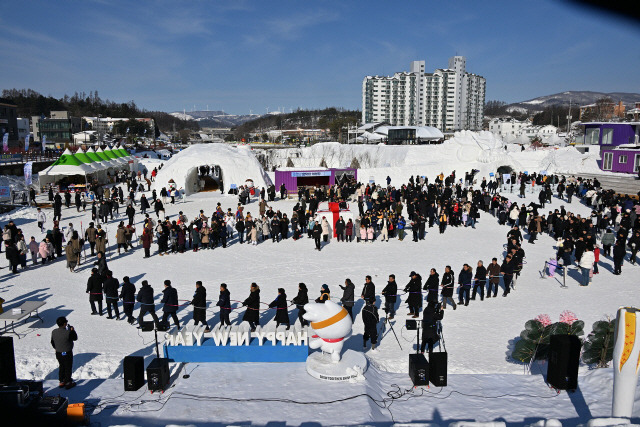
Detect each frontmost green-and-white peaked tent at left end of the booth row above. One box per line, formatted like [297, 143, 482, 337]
[38, 149, 104, 189]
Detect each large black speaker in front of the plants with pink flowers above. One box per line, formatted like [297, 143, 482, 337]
[547, 335, 582, 390]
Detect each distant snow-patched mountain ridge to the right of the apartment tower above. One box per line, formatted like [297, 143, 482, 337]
[506, 91, 640, 113]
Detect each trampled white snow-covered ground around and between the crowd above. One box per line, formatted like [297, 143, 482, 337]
[0, 142, 640, 426]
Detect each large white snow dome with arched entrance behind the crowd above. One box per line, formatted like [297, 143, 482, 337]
[153, 144, 271, 195]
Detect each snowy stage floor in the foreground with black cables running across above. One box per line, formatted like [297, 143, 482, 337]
[42, 364, 640, 426]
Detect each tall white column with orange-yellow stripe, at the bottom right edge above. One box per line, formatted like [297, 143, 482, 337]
[611, 307, 640, 418]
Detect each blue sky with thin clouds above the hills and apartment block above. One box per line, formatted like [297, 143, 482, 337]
[0, 0, 640, 113]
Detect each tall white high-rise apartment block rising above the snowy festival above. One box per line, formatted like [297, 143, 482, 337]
[362, 56, 486, 132]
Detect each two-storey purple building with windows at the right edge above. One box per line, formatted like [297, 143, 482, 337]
[583, 122, 640, 174]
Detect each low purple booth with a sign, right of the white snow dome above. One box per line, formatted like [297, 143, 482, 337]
[275, 168, 358, 194]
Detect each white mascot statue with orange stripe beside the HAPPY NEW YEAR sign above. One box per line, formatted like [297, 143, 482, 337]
[302, 300, 353, 363]
